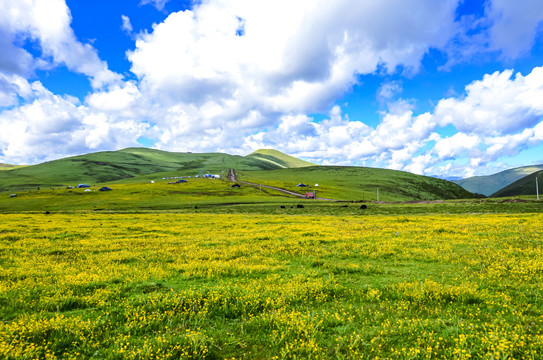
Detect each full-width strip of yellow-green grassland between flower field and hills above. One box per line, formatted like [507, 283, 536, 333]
[0, 174, 543, 216]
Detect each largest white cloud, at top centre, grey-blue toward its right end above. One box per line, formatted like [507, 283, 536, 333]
[128, 0, 462, 113]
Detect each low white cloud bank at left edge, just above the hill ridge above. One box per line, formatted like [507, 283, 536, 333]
[0, 82, 148, 164]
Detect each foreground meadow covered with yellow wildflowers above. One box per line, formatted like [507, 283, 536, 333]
[0, 213, 543, 359]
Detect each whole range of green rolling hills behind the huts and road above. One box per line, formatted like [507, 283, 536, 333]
[0, 148, 474, 201]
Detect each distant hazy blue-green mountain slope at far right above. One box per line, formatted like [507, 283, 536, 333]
[453, 165, 543, 196]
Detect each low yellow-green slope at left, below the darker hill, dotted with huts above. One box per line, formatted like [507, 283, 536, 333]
[0, 178, 306, 213]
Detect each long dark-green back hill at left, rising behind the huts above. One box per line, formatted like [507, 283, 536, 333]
[0, 148, 278, 190]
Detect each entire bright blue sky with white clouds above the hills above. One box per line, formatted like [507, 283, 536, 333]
[0, 0, 543, 177]
